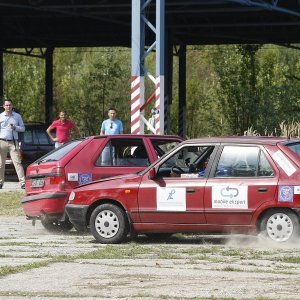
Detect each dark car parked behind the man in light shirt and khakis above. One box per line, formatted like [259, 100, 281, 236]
[5, 123, 54, 174]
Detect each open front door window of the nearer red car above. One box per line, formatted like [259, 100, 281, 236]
[157, 145, 215, 178]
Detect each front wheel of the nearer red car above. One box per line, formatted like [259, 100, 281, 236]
[90, 204, 129, 244]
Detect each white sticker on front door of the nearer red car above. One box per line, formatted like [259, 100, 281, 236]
[156, 187, 186, 211]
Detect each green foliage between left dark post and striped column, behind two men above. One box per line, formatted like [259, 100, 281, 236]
[55, 48, 130, 136]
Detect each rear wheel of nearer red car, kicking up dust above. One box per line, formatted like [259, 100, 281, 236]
[260, 208, 299, 242]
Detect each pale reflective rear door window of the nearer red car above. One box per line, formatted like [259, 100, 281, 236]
[215, 146, 274, 177]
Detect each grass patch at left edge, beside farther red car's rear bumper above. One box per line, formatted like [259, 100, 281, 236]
[0, 192, 24, 216]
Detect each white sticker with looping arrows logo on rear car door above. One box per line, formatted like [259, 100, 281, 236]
[212, 185, 248, 209]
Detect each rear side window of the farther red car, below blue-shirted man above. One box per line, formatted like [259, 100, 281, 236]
[95, 139, 149, 167]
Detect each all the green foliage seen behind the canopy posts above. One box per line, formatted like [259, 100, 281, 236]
[4, 45, 300, 137]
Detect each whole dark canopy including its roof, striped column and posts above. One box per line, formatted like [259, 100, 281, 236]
[0, 0, 300, 135]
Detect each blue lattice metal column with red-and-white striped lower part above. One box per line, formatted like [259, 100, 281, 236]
[131, 0, 165, 134]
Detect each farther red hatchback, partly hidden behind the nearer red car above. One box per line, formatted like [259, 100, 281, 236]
[21, 134, 182, 231]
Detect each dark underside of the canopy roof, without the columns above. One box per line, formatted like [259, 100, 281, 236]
[0, 0, 300, 48]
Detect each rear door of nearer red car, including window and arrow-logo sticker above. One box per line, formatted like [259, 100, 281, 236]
[204, 145, 278, 225]
